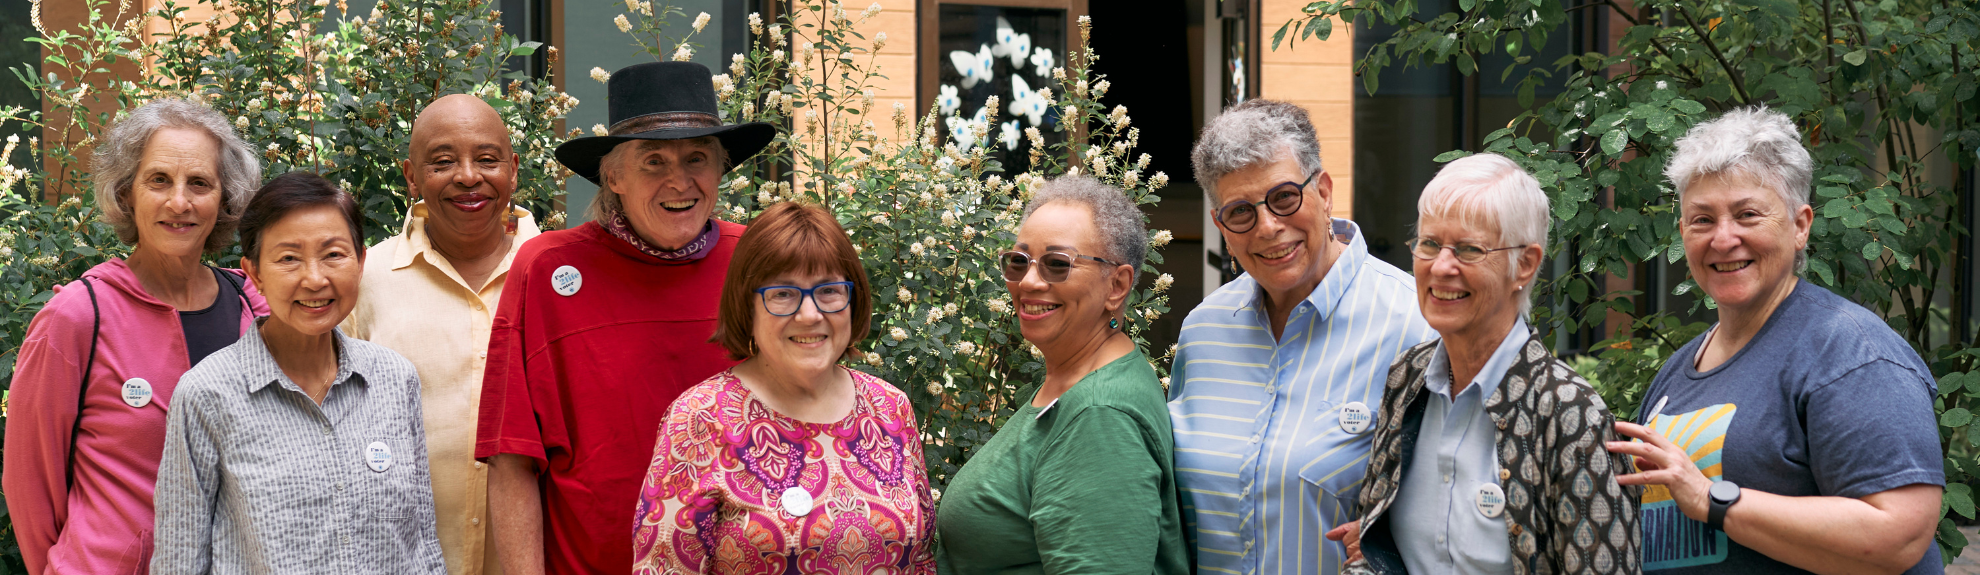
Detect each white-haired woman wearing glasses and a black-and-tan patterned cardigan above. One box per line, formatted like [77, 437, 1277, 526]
[1329, 155, 1641, 573]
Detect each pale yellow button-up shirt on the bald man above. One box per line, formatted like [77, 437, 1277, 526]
[343, 202, 538, 575]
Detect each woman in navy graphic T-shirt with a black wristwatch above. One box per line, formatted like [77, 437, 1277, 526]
[1608, 107, 1946, 573]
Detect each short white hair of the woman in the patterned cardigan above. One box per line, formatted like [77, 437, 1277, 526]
[1416, 153, 1552, 315]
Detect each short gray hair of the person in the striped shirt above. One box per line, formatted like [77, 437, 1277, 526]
[1190, 97, 1321, 203]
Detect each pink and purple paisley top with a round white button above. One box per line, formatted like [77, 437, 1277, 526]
[634, 371, 935, 573]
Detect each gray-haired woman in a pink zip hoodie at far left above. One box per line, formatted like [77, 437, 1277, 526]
[0, 99, 267, 573]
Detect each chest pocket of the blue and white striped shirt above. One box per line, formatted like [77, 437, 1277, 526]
[1293, 403, 1376, 521]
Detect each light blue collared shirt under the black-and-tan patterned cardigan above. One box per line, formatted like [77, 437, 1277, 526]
[1382, 319, 1527, 575]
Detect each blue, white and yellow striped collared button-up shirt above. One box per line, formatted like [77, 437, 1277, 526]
[1168, 218, 1437, 575]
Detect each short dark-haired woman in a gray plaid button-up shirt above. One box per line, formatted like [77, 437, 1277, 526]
[150, 173, 446, 575]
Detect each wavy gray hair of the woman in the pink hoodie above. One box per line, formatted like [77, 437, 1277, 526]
[89, 97, 261, 254]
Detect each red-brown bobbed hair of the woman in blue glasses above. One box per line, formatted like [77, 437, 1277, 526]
[709, 202, 873, 359]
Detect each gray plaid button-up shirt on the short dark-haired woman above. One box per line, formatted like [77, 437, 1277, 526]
[150, 323, 446, 575]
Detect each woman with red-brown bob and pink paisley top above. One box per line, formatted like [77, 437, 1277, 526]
[634, 202, 935, 573]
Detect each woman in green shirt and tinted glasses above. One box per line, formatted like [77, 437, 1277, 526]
[937, 176, 1190, 575]
